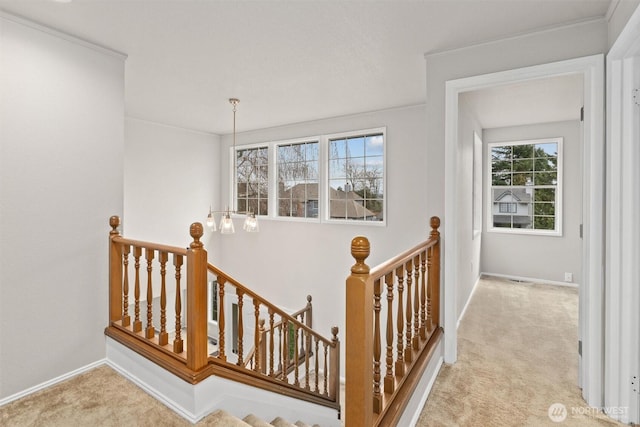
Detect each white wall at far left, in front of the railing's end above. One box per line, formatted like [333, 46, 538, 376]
[0, 15, 125, 399]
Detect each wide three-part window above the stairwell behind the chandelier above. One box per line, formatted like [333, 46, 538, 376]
[231, 128, 386, 225]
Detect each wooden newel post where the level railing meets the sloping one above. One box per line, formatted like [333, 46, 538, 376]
[186, 222, 209, 371]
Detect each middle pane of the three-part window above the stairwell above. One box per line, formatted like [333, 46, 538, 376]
[276, 141, 319, 218]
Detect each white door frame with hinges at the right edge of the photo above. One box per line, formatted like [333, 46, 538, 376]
[604, 8, 640, 423]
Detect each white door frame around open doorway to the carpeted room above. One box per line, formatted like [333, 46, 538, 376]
[443, 54, 605, 408]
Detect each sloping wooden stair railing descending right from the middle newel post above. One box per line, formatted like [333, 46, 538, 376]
[208, 264, 340, 409]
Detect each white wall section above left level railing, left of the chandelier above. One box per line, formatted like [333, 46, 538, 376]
[122, 118, 220, 252]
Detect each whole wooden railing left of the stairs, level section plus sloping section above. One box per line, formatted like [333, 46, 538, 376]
[105, 216, 340, 411]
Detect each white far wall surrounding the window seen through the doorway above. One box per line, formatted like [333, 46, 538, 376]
[481, 120, 582, 283]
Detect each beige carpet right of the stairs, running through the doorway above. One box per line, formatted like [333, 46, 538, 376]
[418, 277, 623, 427]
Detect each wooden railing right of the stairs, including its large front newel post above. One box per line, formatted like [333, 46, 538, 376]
[344, 217, 443, 427]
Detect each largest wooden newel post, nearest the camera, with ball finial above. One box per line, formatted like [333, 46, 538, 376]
[345, 236, 373, 426]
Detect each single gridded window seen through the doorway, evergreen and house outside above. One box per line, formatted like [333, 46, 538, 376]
[488, 138, 562, 235]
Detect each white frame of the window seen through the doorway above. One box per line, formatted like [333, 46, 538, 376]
[485, 137, 564, 237]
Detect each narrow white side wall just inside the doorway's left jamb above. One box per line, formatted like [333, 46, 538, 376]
[456, 94, 482, 319]
